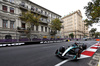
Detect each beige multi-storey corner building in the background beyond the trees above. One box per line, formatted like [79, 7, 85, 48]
[62, 10, 88, 38]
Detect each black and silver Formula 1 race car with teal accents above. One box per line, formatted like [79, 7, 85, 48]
[55, 43, 87, 60]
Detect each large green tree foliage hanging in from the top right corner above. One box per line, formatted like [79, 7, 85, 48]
[84, 0, 100, 26]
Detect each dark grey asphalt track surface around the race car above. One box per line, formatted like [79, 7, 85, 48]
[0, 41, 97, 66]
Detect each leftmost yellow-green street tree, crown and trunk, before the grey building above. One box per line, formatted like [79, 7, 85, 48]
[19, 11, 40, 38]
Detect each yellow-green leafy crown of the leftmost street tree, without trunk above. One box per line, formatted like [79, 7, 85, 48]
[20, 11, 40, 27]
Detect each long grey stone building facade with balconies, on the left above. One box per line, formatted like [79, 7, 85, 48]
[0, 0, 61, 39]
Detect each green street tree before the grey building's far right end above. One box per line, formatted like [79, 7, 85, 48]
[50, 18, 62, 35]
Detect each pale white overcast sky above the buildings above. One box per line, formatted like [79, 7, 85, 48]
[30, 0, 100, 31]
